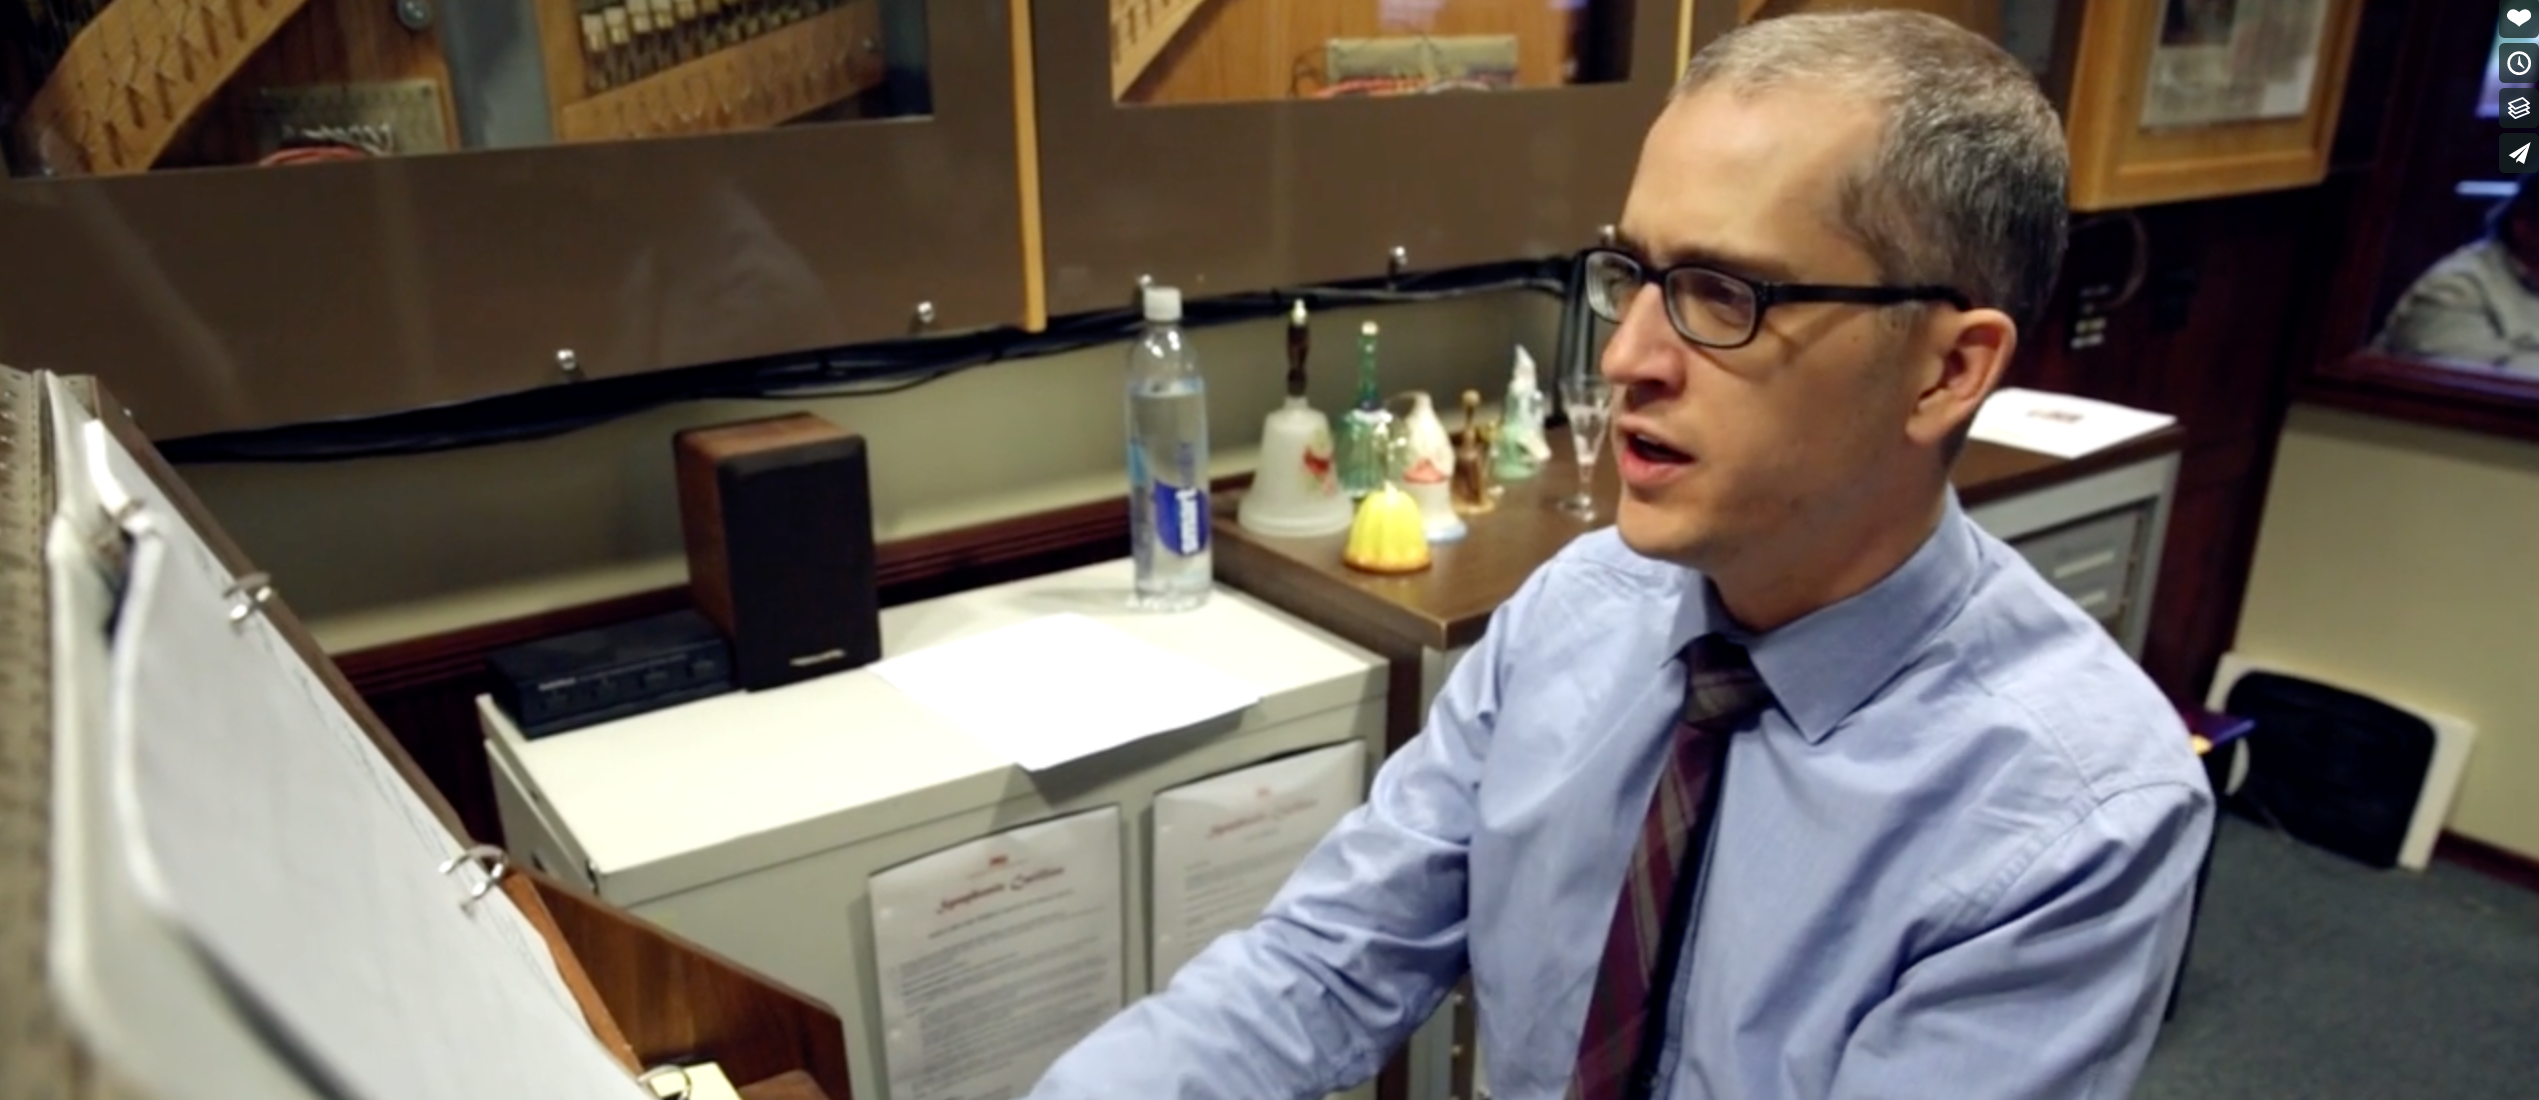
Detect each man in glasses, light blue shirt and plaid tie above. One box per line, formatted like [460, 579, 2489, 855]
[1033, 13, 2211, 1100]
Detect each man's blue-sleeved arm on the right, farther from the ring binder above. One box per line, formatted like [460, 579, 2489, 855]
[1833, 782, 2214, 1100]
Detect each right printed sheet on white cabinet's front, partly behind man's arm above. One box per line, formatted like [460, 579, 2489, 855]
[1148, 742, 1366, 988]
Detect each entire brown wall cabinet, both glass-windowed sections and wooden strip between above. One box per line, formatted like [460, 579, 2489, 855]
[0, 0, 1737, 439]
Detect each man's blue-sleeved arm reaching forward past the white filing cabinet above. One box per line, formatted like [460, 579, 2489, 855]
[1031, 584, 1531, 1100]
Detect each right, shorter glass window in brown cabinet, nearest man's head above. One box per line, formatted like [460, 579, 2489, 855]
[1110, 0, 1630, 104]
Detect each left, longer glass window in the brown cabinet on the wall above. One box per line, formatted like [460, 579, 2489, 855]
[0, 0, 932, 175]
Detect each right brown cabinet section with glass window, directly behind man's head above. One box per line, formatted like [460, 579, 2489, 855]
[1033, 0, 1734, 312]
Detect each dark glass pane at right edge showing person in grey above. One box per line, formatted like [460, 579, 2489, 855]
[2371, 32, 2539, 379]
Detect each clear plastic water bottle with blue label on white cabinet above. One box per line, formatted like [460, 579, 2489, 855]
[1127, 287, 1214, 612]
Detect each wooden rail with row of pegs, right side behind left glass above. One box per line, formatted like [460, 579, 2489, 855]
[556, 0, 884, 142]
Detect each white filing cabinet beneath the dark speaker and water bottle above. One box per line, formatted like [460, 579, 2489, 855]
[477, 559, 1386, 1100]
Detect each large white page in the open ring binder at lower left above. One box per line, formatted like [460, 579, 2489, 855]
[109, 485, 645, 1100]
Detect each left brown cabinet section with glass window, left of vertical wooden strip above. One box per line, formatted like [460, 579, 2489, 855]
[0, 0, 1031, 439]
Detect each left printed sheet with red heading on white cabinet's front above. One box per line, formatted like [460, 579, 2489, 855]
[871, 805, 1127, 1100]
